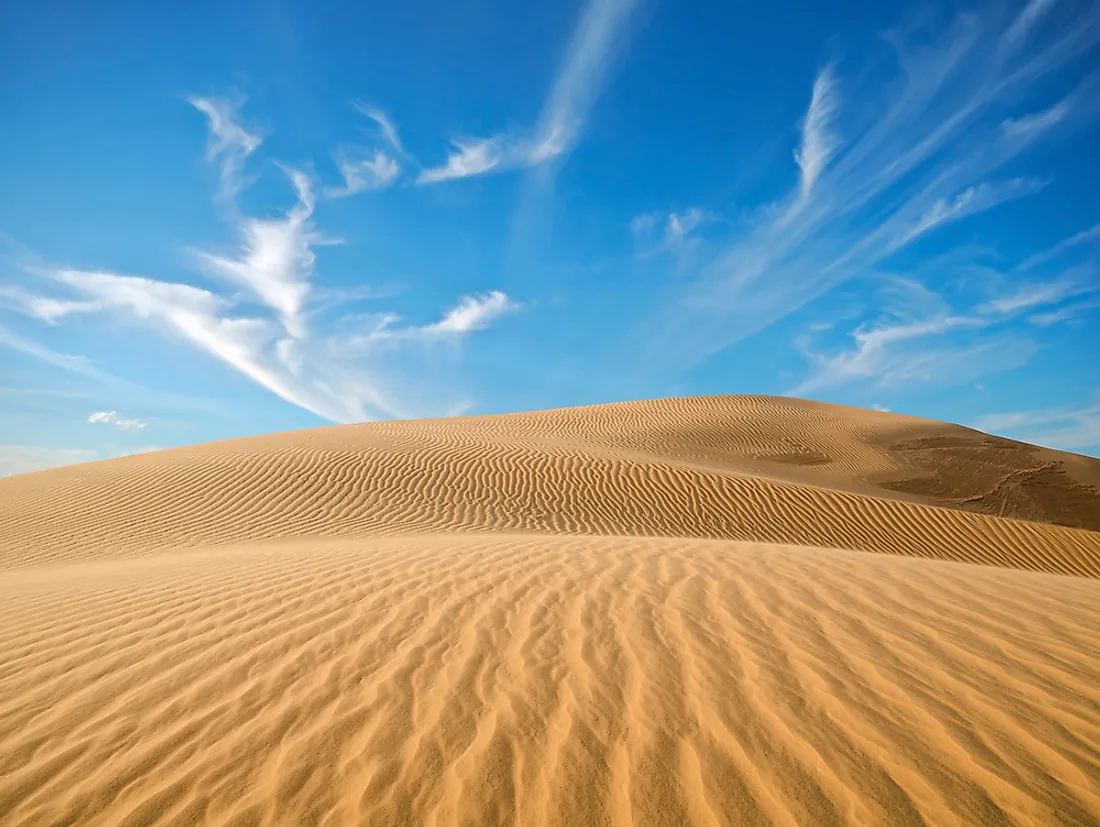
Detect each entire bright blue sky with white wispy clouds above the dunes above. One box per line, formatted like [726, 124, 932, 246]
[0, 0, 1100, 475]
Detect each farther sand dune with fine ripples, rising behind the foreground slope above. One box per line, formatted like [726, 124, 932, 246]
[0, 397, 1100, 576]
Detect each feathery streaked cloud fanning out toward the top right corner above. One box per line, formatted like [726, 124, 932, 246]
[646, 4, 1100, 367]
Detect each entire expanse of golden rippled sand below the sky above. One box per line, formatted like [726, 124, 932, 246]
[0, 397, 1100, 825]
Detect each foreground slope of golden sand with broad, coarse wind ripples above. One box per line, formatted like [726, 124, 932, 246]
[0, 537, 1100, 825]
